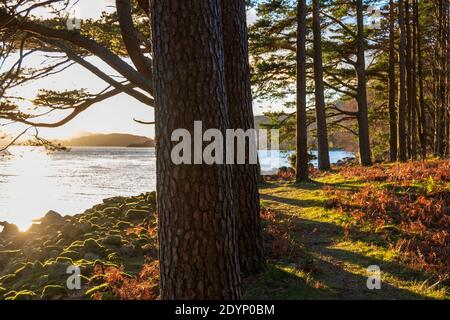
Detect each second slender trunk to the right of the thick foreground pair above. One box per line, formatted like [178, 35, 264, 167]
[313, 0, 330, 170]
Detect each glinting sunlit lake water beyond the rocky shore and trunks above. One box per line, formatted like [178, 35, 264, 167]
[0, 147, 352, 230]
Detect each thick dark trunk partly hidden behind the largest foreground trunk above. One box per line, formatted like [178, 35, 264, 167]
[221, 0, 265, 275]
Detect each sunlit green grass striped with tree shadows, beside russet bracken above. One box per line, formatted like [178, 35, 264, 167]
[245, 173, 450, 299]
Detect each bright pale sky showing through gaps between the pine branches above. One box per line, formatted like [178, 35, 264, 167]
[0, 0, 267, 139]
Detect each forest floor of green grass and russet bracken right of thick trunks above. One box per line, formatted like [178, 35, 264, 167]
[245, 161, 450, 299]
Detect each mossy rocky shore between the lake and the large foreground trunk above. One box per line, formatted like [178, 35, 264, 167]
[0, 192, 157, 300]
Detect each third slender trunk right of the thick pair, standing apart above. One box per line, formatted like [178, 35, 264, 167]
[356, 0, 372, 166]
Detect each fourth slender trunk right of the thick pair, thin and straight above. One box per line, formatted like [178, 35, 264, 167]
[389, 0, 398, 162]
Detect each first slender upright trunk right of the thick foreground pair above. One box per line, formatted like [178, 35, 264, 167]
[296, 0, 309, 182]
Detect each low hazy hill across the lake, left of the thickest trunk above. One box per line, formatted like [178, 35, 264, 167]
[60, 133, 155, 148]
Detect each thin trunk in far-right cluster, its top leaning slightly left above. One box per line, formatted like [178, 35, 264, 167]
[414, 0, 428, 159]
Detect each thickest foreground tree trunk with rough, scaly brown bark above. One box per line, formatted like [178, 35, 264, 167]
[151, 0, 241, 299]
